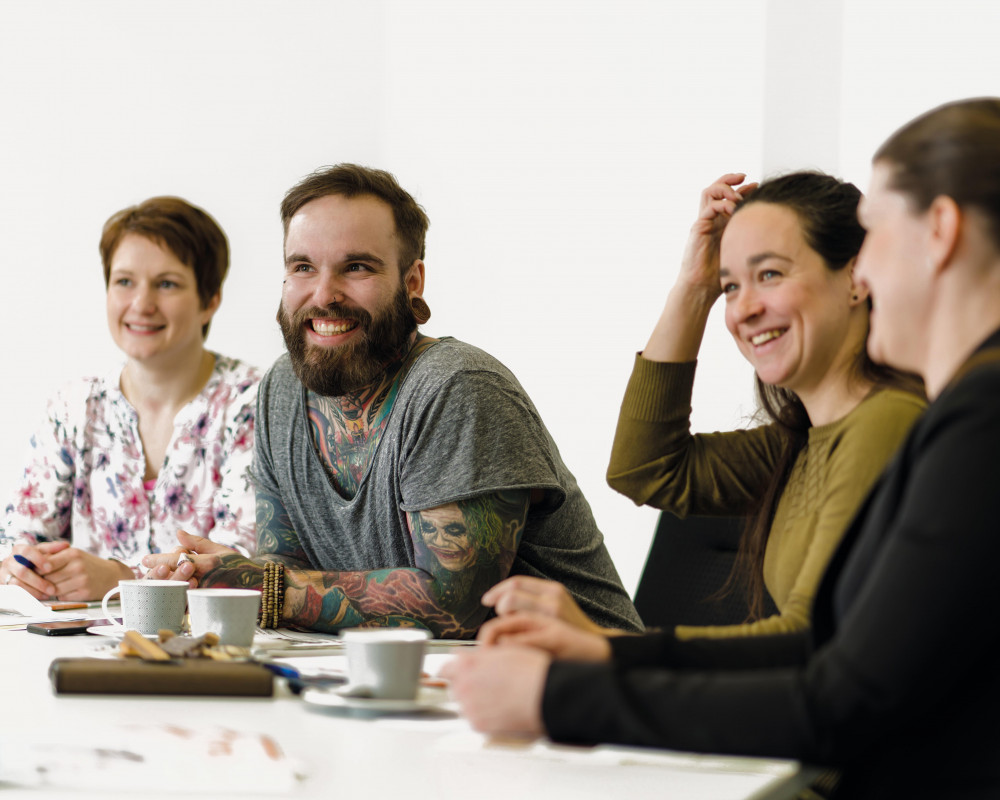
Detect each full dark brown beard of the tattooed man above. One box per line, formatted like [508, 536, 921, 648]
[278, 286, 417, 397]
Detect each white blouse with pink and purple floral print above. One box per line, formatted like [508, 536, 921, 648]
[0, 355, 260, 575]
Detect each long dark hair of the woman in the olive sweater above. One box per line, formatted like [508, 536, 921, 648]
[722, 172, 923, 620]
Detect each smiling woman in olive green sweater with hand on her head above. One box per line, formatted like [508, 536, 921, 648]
[483, 173, 924, 638]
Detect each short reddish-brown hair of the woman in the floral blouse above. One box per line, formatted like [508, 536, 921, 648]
[100, 197, 229, 337]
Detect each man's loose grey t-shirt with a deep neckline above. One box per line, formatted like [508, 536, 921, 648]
[254, 338, 641, 630]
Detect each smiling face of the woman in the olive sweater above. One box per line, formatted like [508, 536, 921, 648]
[720, 202, 857, 397]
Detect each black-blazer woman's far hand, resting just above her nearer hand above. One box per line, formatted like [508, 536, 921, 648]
[476, 612, 611, 661]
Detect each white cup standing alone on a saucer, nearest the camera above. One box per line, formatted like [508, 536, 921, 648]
[341, 628, 431, 700]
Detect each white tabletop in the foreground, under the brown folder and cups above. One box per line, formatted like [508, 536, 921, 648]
[0, 608, 807, 800]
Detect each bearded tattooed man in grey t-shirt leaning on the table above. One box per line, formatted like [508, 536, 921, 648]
[144, 164, 641, 638]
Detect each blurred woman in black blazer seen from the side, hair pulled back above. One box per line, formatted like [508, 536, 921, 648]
[447, 98, 1000, 798]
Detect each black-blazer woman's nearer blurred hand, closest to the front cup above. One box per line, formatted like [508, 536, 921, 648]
[440, 647, 551, 737]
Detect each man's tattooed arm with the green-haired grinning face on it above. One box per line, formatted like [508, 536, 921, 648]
[202, 490, 530, 638]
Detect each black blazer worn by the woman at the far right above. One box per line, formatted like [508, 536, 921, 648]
[542, 331, 1000, 798]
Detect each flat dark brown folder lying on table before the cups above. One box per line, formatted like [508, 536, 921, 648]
[49, 658, 274, 697]
